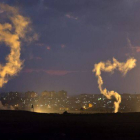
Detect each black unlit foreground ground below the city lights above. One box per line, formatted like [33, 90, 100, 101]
[0, 111, 140, 140]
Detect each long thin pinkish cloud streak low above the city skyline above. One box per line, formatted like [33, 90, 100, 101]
[23, 68, 78, 76]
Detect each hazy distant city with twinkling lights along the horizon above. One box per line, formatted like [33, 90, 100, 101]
[0, 90, 140, 113]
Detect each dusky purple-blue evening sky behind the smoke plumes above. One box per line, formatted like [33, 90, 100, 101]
[0, 0, 140, 95]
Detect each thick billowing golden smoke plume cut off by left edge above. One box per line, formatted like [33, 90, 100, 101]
[0, 4, 35, 87]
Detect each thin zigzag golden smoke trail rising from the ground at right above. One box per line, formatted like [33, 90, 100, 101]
[93, 58, 136, 113]
